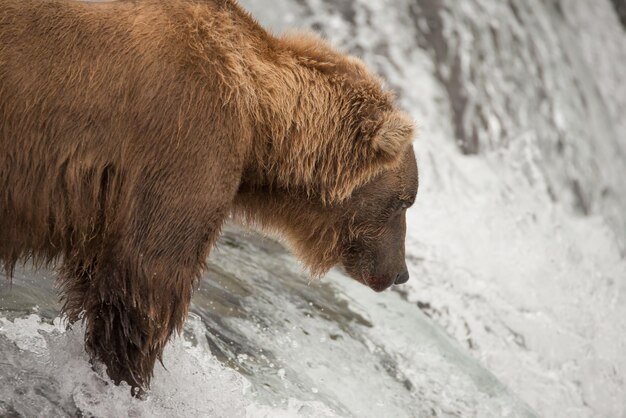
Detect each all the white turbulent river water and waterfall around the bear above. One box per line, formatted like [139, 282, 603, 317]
[0, 0, 626, 417]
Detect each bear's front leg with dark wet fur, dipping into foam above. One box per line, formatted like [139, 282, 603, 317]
[55, 148, 238, 390]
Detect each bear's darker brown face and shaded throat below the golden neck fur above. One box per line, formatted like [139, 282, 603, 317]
[233, 146, 418, 291]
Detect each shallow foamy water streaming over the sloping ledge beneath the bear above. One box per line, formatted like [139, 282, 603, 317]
[0, 228, 532, 417]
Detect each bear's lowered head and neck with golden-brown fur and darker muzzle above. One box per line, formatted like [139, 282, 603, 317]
[233, 31, 418, 291]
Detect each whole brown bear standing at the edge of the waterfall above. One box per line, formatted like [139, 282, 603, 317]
[0, 0, 417, 388]
